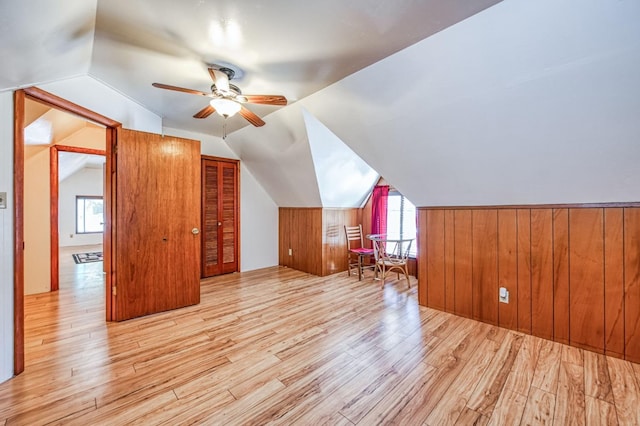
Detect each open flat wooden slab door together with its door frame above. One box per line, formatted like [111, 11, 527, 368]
[14, 88, 201, 374]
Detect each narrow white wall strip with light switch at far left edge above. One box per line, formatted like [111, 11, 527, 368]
[0, 92, 13, 382]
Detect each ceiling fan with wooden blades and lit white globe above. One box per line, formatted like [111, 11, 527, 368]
[152, 67, 287, 127]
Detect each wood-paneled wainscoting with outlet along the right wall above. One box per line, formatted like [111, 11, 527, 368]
[418, 203, 640, 363]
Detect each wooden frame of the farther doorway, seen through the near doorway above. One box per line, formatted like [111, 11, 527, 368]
[49, 145, 106, 291]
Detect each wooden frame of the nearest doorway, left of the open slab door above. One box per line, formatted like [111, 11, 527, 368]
[13, 87, 122, 375]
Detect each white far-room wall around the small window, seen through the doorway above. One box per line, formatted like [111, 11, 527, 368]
[58, 167, 104, 247]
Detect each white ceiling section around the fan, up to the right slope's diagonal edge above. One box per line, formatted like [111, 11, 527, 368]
[0, 0, 499, 136]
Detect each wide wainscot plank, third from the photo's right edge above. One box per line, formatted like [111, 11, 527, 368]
[558, 209, 604, 352]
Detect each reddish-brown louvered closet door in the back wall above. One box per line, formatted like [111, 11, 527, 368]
[202, 157, 238, 277]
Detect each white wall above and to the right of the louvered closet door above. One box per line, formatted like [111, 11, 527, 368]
[164, 128, 278, 271]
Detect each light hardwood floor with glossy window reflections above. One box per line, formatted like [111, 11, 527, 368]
[0, 255, 640, 425]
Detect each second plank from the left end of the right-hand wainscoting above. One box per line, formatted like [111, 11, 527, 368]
[427, 210, 445, 310]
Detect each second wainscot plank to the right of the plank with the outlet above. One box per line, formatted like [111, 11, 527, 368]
[531, 209, 553, 340]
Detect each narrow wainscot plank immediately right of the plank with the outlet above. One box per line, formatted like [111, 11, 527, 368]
[516, 209, 531, 334]
